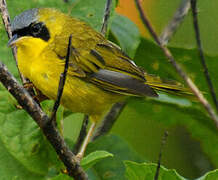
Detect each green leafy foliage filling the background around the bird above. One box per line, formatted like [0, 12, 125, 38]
[0, 0, 218, 180]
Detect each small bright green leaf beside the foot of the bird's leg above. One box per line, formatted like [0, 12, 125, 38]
[81, 151, 113, 170]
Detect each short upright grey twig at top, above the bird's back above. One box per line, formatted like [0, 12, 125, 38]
[101, 0, 112, 36]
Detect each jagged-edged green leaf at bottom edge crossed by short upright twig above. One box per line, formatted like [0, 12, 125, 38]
[124, 161, 185, 180]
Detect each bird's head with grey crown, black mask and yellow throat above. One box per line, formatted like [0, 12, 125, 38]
[8, 8, 68, 48]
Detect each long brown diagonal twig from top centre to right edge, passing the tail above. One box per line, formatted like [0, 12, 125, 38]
[135, 0, 218, 128]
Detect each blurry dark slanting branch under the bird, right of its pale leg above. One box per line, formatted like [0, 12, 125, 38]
[92, 102, 126, 141]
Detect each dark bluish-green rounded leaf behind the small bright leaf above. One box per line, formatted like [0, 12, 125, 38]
[87, 135, 144, 180]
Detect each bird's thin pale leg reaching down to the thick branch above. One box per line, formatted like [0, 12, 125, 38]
[76, 122, 96, 161]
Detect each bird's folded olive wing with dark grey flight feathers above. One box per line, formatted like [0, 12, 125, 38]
[53, 34, 157, 96]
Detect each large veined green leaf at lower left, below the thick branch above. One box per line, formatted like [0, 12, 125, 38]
[0, 88, 60, 179]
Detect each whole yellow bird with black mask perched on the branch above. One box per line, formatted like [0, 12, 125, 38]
[8, 8, 190, 156]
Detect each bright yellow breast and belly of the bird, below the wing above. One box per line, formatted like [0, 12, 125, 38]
[17, 44, 124, 121]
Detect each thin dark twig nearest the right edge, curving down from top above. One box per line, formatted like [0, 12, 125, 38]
[191, 0, 218, 110]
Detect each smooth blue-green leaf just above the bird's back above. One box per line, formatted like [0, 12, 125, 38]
[111, 14, 141, 58]
